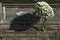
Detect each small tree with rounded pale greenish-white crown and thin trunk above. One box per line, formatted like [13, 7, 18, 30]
[34, 1, 54, 31]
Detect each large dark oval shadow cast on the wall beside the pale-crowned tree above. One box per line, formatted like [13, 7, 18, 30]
[10, 13, 40, 31]
